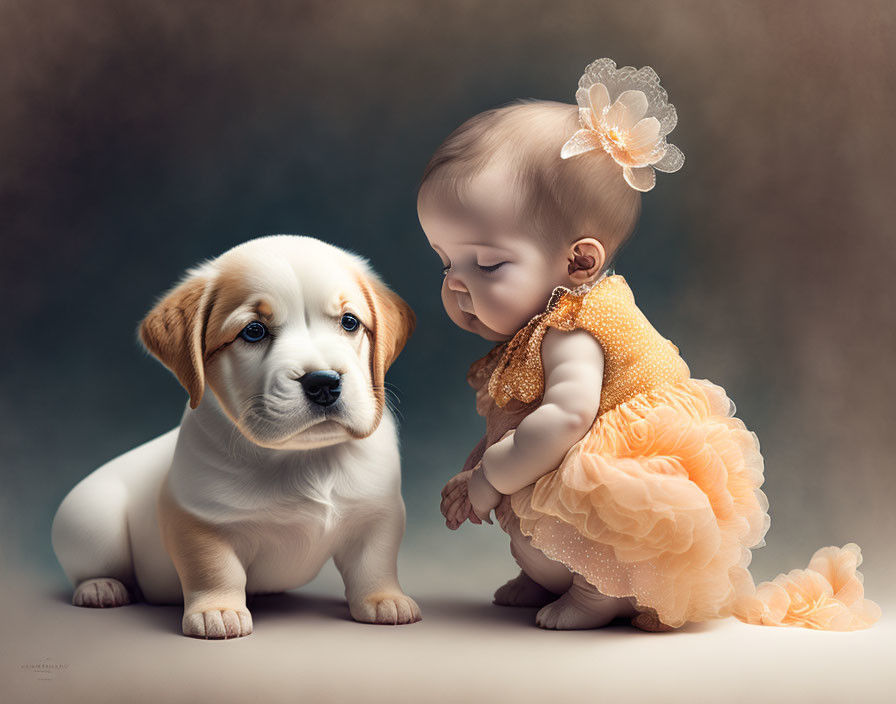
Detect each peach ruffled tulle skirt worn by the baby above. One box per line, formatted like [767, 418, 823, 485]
[511, 379, 769, 627]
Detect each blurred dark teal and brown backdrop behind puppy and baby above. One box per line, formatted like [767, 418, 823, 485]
[0, 0, 896, 601]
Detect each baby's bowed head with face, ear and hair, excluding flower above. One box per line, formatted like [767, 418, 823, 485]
[417, 101, 641, 341]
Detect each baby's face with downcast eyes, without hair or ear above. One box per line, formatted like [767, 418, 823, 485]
[417, 168, 568, 341]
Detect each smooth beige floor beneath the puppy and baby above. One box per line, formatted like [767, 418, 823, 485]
[0, 555, 896, 704]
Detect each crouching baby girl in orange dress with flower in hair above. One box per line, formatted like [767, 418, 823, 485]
[418, 59, 879, 631]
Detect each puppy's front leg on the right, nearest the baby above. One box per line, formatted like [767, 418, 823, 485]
[333, 506, 421, 625]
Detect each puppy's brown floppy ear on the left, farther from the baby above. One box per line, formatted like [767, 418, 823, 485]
[139, 273, 213, 408]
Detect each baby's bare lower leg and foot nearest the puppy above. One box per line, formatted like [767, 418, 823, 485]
[495, 517, 573, 606]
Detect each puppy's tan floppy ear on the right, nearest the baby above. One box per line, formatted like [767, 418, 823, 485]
[359, 275, 417, 424]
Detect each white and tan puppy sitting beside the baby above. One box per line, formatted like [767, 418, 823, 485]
[52, 235, 420, 638]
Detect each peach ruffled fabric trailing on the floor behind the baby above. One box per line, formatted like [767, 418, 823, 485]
[734, 543, 881, 631]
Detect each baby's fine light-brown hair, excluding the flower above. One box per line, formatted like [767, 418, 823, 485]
[420, 100, 641, 269]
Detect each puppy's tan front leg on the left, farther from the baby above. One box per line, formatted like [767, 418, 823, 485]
[158, 480, 252, 638]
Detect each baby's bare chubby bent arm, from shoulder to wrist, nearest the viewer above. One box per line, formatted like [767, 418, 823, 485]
[482, 328, 604, 494]
